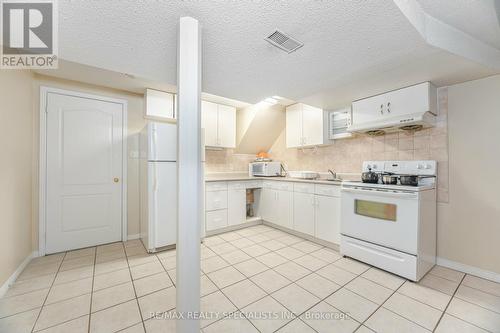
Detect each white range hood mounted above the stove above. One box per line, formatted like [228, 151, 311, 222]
[347, 111, 436, 135]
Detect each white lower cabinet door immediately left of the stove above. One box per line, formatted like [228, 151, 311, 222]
[314, 195, 340, 244]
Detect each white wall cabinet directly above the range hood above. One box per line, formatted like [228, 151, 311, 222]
[352, 82, 436, 125]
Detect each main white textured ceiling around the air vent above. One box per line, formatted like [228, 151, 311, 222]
[59, 0, 493, 108]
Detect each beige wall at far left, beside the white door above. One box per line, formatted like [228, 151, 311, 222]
[0, 70, 33, 286]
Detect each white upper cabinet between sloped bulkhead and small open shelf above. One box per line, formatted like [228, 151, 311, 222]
[286, 103, 328, 148]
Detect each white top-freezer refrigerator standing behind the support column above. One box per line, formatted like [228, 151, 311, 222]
[139, 122, 177, 252]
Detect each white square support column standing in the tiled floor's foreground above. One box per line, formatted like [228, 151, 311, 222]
[177, 17, 203, 333]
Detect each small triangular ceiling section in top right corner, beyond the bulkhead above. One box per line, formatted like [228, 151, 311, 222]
[418, 0, 500, 49]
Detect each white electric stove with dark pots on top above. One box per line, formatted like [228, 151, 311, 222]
[340, 161, 437, 281]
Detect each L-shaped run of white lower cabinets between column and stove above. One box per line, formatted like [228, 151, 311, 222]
[205, 180, 340, 244]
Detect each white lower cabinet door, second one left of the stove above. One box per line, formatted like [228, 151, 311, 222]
[293, 192, 314, 236]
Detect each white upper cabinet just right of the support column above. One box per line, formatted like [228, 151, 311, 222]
[201, 101, 236, 148]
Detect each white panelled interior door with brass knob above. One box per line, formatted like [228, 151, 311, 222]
[45, 92, 123, 253]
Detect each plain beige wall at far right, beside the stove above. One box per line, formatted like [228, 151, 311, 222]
[438, 75, 500, 274]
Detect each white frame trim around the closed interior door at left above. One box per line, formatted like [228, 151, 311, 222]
[38, 86, 128, 256]
